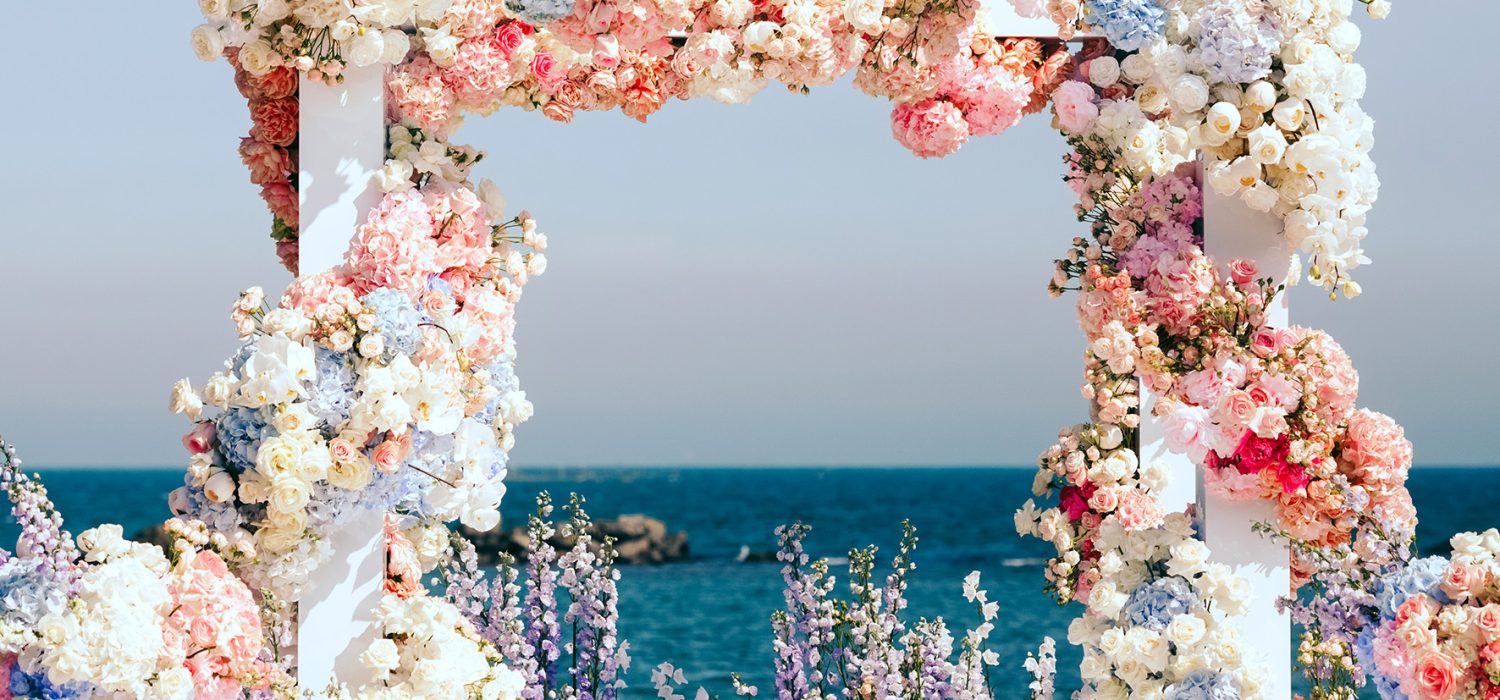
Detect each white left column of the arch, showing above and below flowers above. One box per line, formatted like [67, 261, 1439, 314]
[297, 66, 386, 691]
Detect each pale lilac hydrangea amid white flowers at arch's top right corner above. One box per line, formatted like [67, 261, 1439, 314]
[1199, 0, 1281, 82]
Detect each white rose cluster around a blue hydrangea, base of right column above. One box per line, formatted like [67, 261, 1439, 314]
[1068, 514, 1266, 700]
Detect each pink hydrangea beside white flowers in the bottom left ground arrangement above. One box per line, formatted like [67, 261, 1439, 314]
[162, 550, 273, 700]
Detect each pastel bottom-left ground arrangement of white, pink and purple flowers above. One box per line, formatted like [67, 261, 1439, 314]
[0, 441, 290, 700]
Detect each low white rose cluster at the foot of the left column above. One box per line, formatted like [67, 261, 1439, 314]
[353, 595, 525, 700]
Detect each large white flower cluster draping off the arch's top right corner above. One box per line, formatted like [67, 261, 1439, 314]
[1074, 0, 1380, 297]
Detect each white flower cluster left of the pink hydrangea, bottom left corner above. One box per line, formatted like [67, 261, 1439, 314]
[21, 525, 194, 700]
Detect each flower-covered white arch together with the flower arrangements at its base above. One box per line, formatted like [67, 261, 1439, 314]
[0, 0, 1500, 699]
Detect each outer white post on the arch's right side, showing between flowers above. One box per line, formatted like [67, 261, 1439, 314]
[1200, 171, 1292, 700]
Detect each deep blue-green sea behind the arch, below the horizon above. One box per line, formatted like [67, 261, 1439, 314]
[0, 466, 1500, 699]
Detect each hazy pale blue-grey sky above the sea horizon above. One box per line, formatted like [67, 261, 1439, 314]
[0, 0, 1500, 466]
